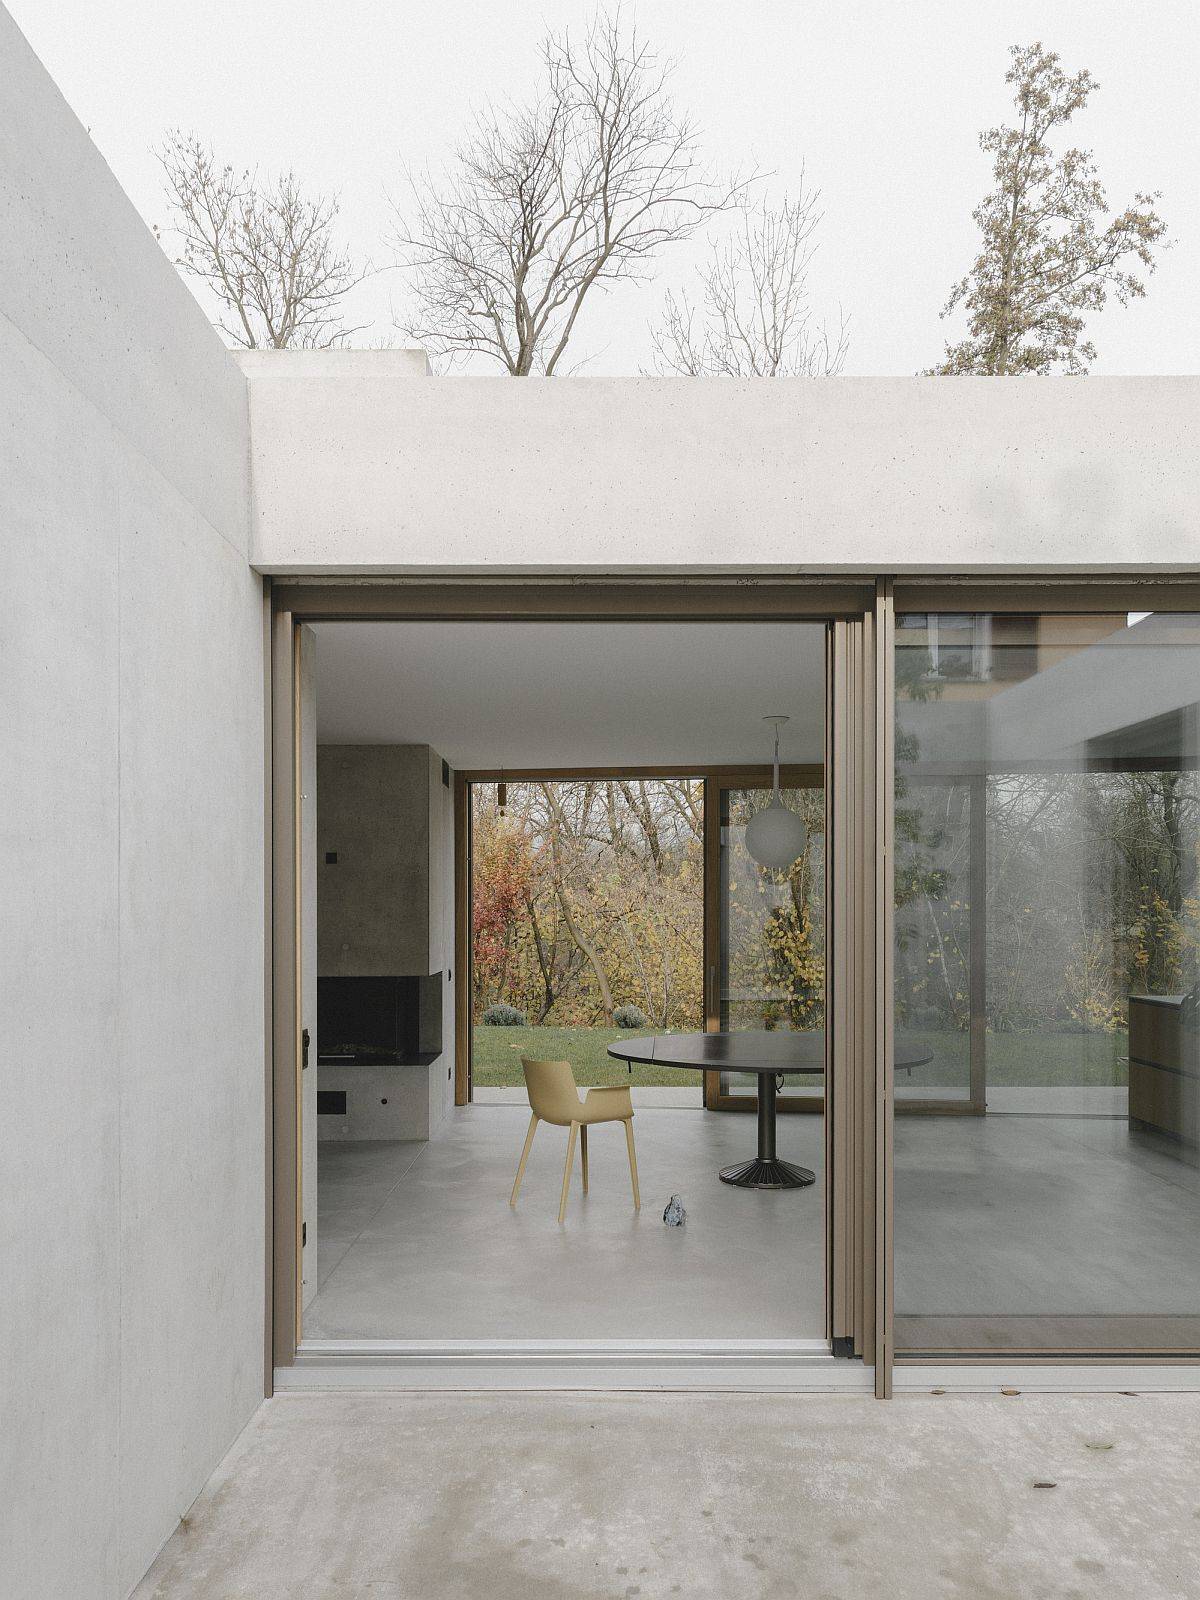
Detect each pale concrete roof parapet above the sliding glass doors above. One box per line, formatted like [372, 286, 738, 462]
[248, 352, 1200, 574]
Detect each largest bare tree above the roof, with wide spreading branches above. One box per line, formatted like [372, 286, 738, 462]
[395, 11, 744, 378]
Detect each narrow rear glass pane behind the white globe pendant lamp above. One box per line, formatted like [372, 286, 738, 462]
[717, 789, 826, 1098]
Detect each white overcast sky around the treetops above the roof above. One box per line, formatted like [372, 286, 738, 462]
[5, 0, 1200, 374]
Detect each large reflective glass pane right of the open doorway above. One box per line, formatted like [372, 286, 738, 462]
[894, 613, 1200, 1352]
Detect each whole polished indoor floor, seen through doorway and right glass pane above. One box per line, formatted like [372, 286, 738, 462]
[304, 1090, 1200, 1350]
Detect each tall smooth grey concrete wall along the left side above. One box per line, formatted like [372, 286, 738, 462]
[0, 10, 264, 1600]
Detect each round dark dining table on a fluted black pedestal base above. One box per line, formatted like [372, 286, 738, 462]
[608, 1029, 933, 1189]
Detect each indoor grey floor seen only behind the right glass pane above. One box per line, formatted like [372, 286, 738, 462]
[896, 1117, 1200, 1349]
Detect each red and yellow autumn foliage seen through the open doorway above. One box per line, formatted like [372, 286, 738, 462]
[472, 778, 824, 1027]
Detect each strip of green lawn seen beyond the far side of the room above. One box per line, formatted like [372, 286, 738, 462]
[475, 1027, 1128, 1088]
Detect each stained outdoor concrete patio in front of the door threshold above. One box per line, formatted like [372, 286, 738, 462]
[134, 1394, 1200, 1600]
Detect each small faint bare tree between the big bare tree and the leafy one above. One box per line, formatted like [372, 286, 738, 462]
[653, 188, 848, 378]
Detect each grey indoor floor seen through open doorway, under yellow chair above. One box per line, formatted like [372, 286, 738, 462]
[304, 1102, 826, 1339]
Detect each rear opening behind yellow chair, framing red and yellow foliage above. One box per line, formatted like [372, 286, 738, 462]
[470, 778, 704, 1106]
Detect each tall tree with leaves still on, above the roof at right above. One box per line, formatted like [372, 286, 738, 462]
[933, 43, 1166, 376]
